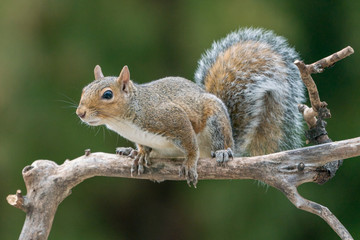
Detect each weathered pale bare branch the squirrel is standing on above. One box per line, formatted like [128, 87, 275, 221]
[8, 137, 360, 239]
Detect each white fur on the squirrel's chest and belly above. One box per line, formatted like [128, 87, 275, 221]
[106, 121, 211, 157]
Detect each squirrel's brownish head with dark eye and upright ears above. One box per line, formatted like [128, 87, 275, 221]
[76, 65, 135, 126]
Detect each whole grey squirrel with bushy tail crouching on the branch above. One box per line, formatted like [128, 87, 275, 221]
[76, 28, 304, 186]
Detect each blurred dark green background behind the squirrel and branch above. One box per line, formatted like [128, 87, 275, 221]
[0, 0, 360, 240]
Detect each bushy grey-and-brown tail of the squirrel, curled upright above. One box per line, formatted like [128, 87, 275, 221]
[195, 28, 304, 156]
